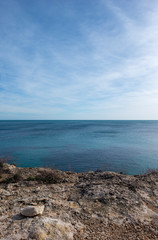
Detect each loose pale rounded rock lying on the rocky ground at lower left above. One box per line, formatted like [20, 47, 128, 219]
[21, 205, 44, 217]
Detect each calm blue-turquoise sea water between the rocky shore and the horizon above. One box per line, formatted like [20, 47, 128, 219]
[0, 120, 158, 174]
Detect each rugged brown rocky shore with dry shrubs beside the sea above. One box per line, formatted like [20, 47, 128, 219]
[0, 163, 158, 240]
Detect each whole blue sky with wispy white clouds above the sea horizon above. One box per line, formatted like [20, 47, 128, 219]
[0, 0, 158, 120]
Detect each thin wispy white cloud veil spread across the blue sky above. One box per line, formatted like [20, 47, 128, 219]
[0, 1, 158, 119]
